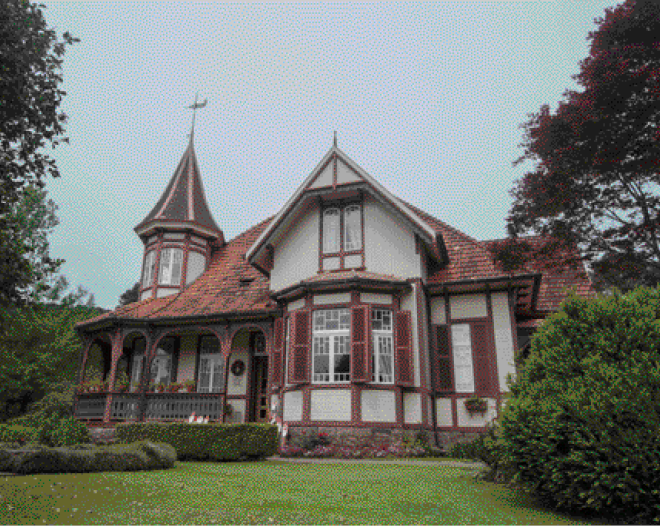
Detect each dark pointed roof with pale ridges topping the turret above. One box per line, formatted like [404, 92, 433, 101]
[135, 137, 223, 239]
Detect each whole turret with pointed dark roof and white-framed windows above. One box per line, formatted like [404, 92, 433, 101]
[135, 137, 225, 300]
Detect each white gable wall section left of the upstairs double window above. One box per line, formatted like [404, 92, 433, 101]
[270, 205, 319, 290]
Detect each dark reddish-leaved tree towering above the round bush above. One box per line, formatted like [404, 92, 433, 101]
[494, 0, 660, 289]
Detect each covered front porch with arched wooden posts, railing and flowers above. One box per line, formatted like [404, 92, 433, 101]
[74, 321, 272, 427]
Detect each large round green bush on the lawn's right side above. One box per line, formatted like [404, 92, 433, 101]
[498, 288, 660, 523]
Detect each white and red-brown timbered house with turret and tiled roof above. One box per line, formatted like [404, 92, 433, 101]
[75, 135, 593, 445]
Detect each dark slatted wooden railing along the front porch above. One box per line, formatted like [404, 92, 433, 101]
[76, 393, 224, 421]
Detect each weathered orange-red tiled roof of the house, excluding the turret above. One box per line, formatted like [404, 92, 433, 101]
[81, 203, 594, 326]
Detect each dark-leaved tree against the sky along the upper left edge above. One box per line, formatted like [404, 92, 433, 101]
[0, 0, 78, 304]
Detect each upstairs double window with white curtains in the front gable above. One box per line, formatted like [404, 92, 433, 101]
[321, 203, 364, 271]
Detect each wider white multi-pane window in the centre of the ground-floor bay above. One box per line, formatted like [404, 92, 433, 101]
[312, 309, 351, 383]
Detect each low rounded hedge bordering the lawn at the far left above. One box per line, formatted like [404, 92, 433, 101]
[0, 441, 177, 475]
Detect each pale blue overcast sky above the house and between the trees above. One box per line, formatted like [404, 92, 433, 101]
[43, 0, 621, 308]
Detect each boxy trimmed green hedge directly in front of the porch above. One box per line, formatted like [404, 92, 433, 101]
[115, 422, 278, 461]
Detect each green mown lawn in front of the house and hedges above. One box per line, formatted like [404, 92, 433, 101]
[0, 461, 603, 524]
